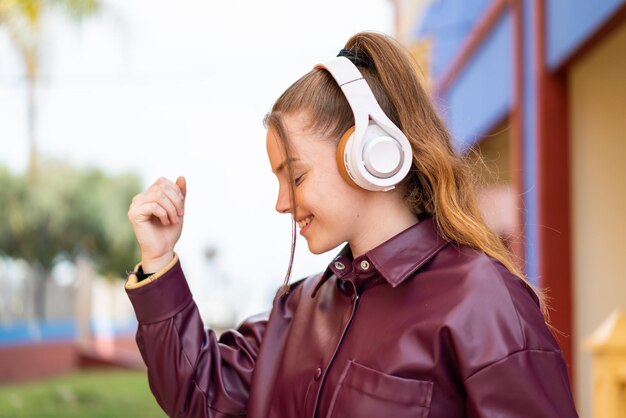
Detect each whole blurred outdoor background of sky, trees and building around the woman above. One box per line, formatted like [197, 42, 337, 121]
[0, 0, 626, 417]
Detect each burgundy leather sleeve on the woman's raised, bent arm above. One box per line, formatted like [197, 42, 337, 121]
[126, 258, 267, 417]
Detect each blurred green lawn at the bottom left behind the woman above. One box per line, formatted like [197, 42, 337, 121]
[0, 370, 165, 418]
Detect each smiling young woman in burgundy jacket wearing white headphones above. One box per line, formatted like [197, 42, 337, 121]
[126, 33, 577, 418]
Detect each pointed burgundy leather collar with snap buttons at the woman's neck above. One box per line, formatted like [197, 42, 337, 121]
[312, 217, 448, 296]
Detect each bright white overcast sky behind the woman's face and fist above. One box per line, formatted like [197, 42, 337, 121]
[0, 0, 393, 320]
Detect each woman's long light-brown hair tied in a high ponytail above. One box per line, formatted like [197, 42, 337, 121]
[265, 32, 547, 318]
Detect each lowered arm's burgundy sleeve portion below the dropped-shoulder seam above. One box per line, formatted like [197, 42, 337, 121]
[465, 350, 578, 418]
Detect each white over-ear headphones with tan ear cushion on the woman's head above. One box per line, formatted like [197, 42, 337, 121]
[315, 56, 413, 192]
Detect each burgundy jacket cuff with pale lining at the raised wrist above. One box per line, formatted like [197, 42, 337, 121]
[125, 257, 192, 324]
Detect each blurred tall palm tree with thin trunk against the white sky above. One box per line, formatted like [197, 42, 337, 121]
[0, 0, 101, 178]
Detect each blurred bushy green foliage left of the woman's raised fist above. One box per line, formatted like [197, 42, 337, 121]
[0, 162, 141, 277]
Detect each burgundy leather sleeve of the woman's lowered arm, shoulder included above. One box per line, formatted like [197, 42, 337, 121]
[452, 258, 578, 418]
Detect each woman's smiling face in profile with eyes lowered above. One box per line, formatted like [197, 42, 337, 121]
[267, 114, 371, 254]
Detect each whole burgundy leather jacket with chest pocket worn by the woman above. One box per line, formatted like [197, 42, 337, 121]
[126, 219, 577, 418]
